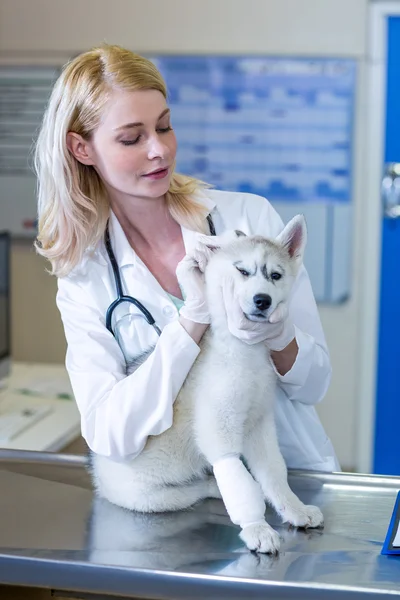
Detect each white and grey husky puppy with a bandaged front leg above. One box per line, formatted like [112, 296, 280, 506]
[92, 216, 323, 553]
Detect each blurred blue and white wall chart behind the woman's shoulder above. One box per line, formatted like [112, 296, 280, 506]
[151, 56, 356, 302]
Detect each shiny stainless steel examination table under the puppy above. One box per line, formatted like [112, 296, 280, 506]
[0, 450, 400, 600]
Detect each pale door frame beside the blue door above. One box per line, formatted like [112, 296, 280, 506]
[356, 0, 400, 473]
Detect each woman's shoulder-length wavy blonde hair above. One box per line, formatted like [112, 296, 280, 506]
[35, 45, 211, 277]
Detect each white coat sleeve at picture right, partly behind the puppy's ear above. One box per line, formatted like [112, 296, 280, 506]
[257, 201, 332, 404]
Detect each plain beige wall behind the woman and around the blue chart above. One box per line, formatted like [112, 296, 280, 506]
[0, 0, 368, 468]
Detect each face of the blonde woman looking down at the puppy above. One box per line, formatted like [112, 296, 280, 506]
[72, 90, 176, 201]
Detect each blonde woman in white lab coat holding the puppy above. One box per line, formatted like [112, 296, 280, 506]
[36, 46, 339, 471]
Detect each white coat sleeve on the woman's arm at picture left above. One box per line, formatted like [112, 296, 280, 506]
[57, 278, 200, 460]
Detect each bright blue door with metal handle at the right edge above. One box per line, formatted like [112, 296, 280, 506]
[373, 17, 400, 475]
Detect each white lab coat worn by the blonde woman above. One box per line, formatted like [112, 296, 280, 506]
[57, 190, 340, 471]
